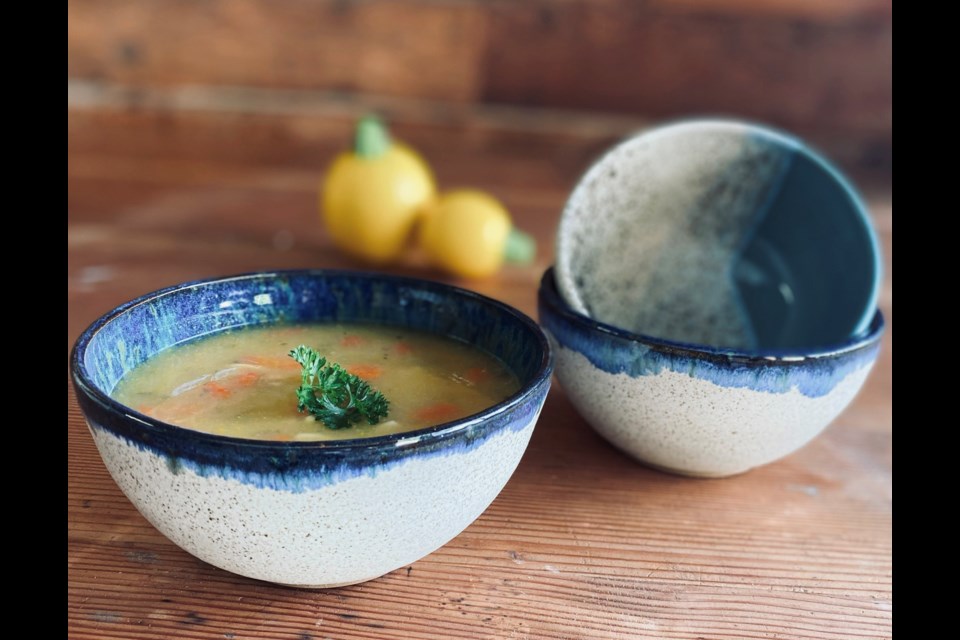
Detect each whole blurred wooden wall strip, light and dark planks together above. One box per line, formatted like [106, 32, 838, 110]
[67, 0, 893, 151]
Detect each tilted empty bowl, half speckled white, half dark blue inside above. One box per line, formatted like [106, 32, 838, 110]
[556, 120, 881, 353]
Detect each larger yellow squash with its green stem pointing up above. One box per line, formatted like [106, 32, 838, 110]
[320, 116, 437, 263]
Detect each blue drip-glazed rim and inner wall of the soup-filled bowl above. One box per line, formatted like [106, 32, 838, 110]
[71, 271, 553, 491]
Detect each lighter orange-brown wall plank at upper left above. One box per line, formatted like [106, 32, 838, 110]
[67, 0, 486, 101]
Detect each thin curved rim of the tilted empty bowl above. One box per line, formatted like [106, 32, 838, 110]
[553, 116, 884, 346]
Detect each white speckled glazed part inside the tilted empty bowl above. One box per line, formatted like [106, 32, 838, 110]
[556, 123, 784, 347]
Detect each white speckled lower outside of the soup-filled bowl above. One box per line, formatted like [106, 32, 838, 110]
[85, 411, 539, 588]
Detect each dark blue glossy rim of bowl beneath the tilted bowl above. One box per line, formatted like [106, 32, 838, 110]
[538, 266, 886, 365]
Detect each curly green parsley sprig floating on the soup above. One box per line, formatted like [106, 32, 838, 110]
[290, 345, 390, 429]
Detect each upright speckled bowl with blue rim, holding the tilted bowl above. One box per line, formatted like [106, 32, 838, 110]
[539, 268, 884, 477]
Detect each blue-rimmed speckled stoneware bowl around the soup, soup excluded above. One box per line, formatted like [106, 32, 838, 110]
[71, 271, 553, 587]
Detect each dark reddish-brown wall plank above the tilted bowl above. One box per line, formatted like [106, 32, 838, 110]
[483, 0, 892, 132]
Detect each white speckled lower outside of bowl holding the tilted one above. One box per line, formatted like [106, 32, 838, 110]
[555, 347, 871, 477]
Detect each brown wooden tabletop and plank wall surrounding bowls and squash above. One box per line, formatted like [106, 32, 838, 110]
[67, 0, 892, 640]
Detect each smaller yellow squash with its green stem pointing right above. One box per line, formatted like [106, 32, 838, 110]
[418, 189, 536, 278]
